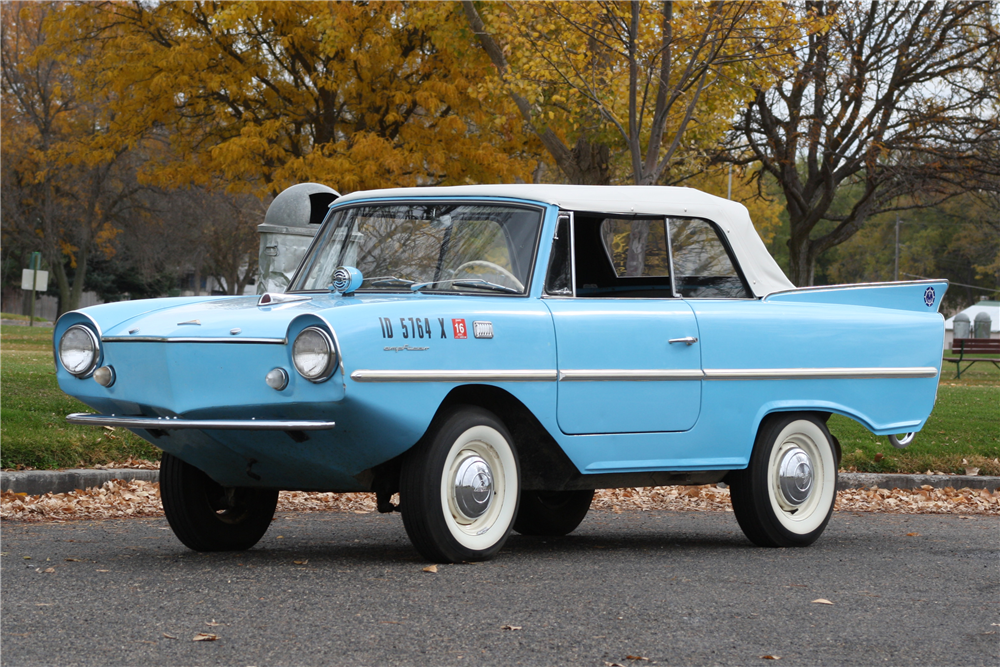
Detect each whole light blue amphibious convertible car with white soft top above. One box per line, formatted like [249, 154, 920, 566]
[55, 185, 947, 562]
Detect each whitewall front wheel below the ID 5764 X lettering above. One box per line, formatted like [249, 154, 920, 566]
[399, 406, 520, 563]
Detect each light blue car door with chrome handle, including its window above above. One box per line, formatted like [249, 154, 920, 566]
[544, 214, 702, 435]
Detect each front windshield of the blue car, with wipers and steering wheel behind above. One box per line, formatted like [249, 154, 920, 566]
[289, 202, 542, 295]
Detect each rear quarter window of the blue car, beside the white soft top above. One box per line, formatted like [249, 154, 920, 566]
[668, 218, 749, 299]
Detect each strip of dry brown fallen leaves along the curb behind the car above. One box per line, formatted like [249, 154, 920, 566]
[0, 480, 1000, 521]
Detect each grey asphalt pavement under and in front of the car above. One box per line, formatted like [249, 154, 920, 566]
[0, 511, 1000, 667]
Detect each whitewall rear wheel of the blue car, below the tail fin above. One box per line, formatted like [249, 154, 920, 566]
[729, 413, 837, 547]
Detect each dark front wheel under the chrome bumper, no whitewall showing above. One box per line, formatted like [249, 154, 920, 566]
[160, 453, 278, 551]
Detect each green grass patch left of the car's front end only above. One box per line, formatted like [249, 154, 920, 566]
[0, 325, 160, 469]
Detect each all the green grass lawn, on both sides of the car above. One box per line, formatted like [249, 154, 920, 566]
[0, 326, 1000, 475]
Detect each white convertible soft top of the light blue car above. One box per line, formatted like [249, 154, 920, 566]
[334, 184, 795, 297]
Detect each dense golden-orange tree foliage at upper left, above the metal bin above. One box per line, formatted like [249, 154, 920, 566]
[49, 1, 534, 195]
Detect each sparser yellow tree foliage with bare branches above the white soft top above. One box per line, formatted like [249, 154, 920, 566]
[467, 0, 821, 184]
